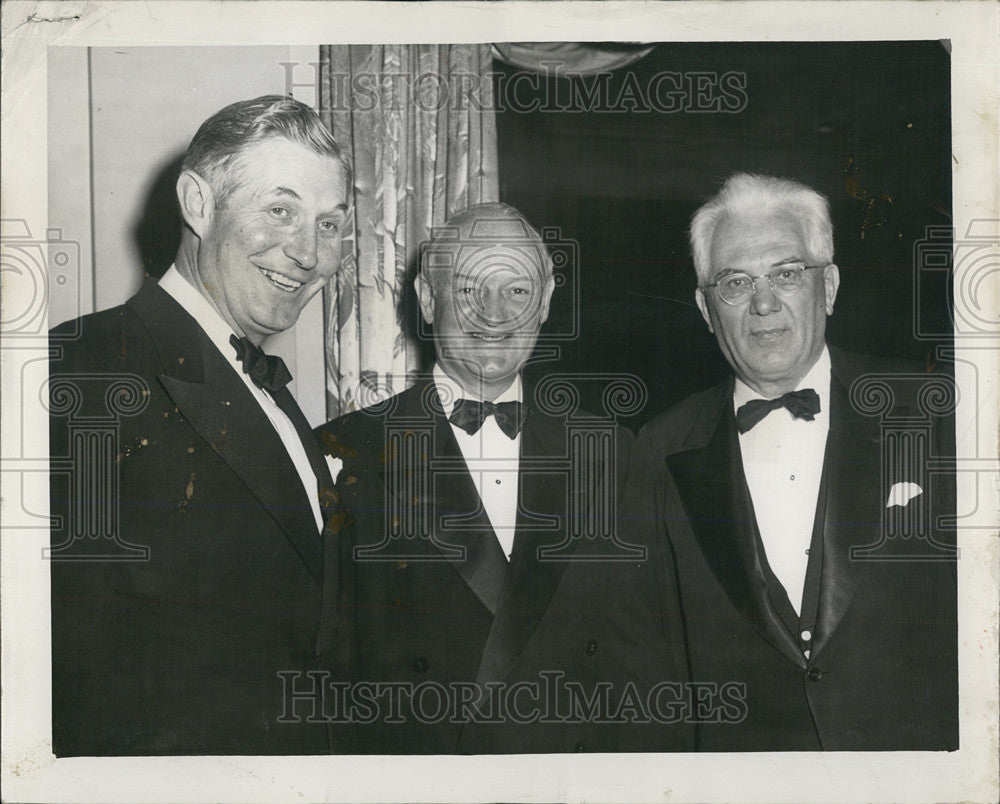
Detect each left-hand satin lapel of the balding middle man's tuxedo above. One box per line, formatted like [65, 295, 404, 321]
[383, 383, 507, 614]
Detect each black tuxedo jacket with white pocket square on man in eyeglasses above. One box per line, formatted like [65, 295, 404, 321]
[639, 348, 958, 751]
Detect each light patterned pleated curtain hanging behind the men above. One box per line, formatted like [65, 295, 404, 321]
[319, 44, 498, 418]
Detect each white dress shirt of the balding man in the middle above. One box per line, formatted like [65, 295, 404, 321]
[434, 365, 521, 561]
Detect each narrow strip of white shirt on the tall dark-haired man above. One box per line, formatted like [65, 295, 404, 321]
[160, 265, 323, 531]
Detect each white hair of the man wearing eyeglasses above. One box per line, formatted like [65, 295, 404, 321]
[691, 173, 833, 282]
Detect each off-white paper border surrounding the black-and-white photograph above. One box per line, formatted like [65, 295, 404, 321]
[0, 0, 1000, 802]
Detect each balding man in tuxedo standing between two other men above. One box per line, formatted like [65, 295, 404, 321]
[319, 204, 690, 754]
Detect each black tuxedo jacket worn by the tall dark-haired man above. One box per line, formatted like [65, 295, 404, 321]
[50, 284, 328, 756]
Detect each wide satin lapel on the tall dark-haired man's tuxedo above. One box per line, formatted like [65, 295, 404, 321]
[129, 285, 323, 582]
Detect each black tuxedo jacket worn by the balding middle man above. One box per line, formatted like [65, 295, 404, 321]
[319, 381, 693, 754]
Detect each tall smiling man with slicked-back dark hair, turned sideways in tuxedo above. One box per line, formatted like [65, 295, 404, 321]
[50, 96, 350, 756]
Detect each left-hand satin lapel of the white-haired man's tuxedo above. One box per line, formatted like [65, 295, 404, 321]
[667, 382, 804, 665]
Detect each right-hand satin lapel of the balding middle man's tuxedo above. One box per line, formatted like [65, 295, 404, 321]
[476, 410, 574, 685]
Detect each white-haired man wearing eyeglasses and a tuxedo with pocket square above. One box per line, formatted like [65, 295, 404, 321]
[633, 174, 958, 751]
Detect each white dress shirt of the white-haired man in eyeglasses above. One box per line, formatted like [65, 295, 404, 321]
[733, 347, 830, 614]
